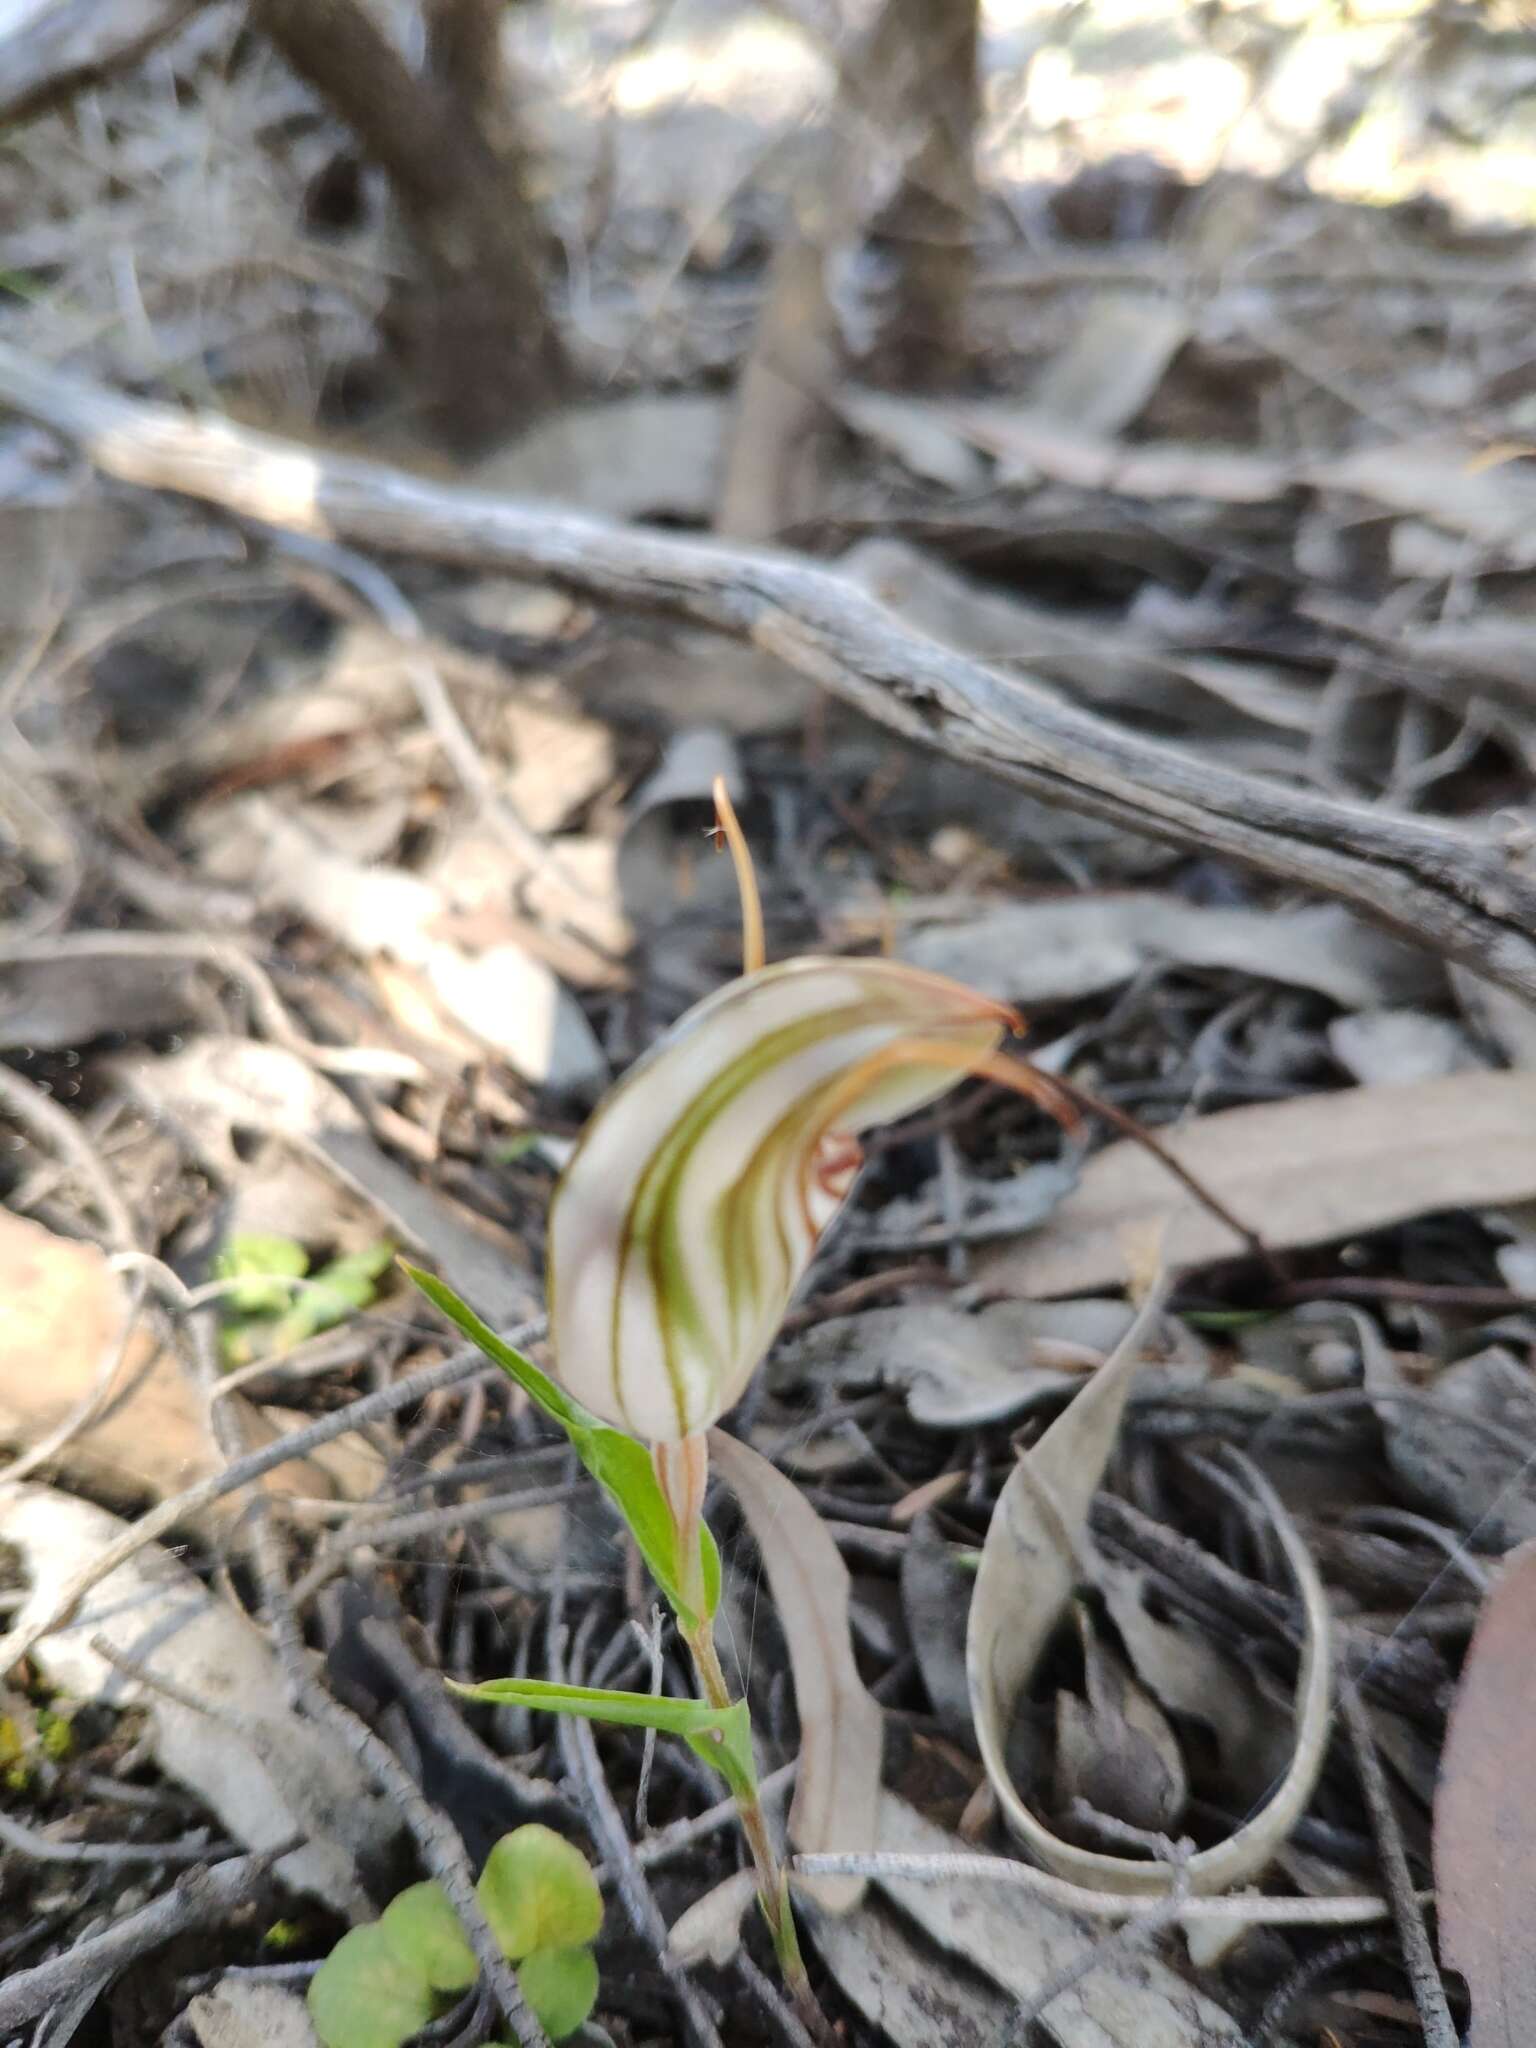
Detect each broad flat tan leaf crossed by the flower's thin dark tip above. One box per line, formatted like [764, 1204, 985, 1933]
[975, 1073, 1536, 1294]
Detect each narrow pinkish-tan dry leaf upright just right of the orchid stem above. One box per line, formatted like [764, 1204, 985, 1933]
[709, 1430, 885, 1913]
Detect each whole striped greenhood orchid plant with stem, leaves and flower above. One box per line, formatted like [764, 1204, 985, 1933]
[416, 782, 1262, 2040]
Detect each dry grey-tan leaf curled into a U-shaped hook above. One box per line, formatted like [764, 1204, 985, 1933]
[965, 1294, 1331, 1894]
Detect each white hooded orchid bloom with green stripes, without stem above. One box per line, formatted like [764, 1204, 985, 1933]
[549, 958, 1016, 1442]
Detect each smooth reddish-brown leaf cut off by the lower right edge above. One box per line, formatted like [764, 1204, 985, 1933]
[1434, 1542, 1536, 2048]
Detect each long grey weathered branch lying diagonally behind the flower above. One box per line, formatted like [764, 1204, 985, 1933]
[0, 346, 1536, 999]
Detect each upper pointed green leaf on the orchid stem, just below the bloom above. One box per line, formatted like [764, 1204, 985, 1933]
[401, 1260, 721, 1628]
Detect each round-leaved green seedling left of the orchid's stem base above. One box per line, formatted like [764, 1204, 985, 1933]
[309, 1821, 602, 2048]
